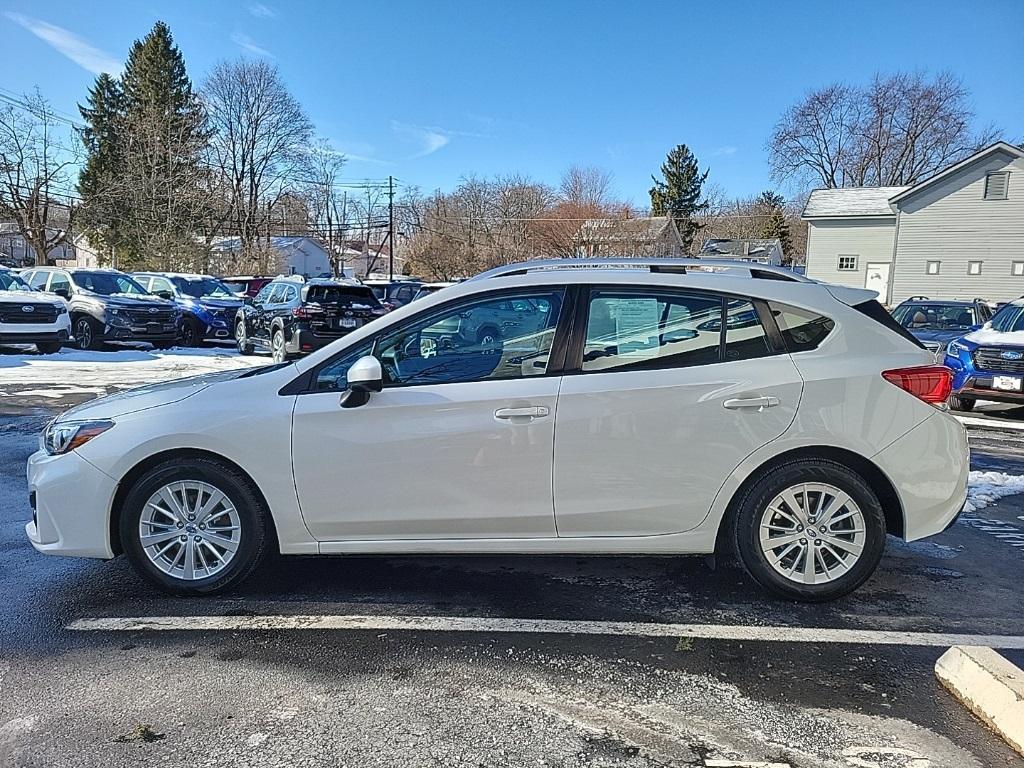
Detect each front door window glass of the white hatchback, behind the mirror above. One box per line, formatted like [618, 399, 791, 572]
[376, 290, 563, 386]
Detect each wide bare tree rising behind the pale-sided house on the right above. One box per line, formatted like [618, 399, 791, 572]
[768, 73, 998, 187]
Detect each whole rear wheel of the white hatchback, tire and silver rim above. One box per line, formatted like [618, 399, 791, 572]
[733, 459, 886, 602]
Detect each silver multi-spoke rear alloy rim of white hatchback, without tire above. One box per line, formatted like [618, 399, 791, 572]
[758, 482, 866, 584]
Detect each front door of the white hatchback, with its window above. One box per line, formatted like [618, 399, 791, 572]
[292, 288, 568, 542]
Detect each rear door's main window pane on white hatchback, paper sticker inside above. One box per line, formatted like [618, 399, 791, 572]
[583, 291, 722, 372]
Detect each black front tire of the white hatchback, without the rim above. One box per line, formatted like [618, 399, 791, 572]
[119, 458, 273, 595]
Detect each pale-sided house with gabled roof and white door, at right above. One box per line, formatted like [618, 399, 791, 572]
[803, 141, 1024, 305]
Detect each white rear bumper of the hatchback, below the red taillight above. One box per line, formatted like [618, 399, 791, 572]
[872, 411, 971, 542]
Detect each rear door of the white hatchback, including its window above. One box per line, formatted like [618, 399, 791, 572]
[554, 287, 802, 537]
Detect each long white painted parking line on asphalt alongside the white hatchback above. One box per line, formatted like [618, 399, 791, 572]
[68, 614, 1024, 649]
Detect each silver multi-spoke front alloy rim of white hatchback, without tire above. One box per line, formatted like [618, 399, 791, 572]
[138, 480, 242, 582]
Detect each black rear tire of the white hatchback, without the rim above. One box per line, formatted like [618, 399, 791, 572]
[732, 459, 886, 602]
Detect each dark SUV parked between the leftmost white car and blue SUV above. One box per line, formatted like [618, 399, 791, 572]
[22, 266, 181, 349]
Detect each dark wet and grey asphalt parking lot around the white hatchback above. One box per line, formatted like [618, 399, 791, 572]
[0, 350, 1024, 768]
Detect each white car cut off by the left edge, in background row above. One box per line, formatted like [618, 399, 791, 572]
[0, 267, 71, 354]
